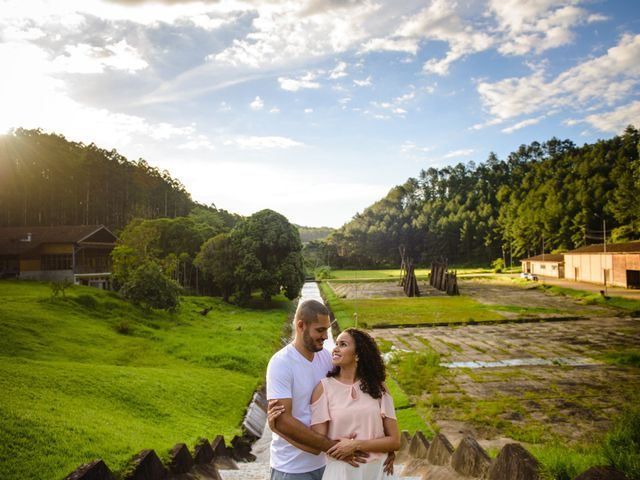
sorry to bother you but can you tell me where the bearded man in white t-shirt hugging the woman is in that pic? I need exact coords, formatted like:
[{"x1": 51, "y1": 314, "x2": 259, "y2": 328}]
[{"x1": 267, "y1": 300, "x2": 334, "y2": 480}]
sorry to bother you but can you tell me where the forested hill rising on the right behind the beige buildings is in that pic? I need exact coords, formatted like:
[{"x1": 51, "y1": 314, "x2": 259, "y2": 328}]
[{"x1": 323, "y1": 126, "x2": 640, "y2": 267}]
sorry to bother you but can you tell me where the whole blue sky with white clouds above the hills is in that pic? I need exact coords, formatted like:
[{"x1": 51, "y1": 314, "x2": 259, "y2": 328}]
[{"x1": 0, "y1": 0, "x2": 640, "y2": 227}]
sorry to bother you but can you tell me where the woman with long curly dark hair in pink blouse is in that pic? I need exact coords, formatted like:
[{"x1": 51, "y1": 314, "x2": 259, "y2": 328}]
[{"x1": 311, "y1": 328, "x2": 400, "y2": 480}]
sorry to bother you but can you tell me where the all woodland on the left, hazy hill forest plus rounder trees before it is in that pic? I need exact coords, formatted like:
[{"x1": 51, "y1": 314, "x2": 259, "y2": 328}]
[{"x1": 0, "y1": 128, "x2": 304, "y2": 309}]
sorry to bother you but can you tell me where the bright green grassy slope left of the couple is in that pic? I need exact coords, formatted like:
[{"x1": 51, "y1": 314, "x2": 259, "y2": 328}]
[{"x1": 0, "y1": 281, "x2": 290, "y2": 479}]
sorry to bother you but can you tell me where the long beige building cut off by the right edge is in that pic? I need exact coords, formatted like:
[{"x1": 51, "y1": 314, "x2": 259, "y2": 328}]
[{"x1": 564, "y1": 241, "x2": 640, "y2": 288}]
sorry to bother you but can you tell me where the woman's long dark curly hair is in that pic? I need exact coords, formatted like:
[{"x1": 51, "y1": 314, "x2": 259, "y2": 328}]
[{"x1": 327, "y1": 328, "x2": 386, "y2": 398}]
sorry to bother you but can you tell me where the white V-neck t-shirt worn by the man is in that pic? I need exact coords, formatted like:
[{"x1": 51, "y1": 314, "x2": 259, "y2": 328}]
[{"x1": 267, "y1": 344, "x2": 333, "y2": 473}]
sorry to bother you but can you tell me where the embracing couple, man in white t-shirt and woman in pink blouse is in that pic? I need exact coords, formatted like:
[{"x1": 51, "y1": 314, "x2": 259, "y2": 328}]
[{"x1": 267, "y1": 300, "x2": 400, "y2": 480}]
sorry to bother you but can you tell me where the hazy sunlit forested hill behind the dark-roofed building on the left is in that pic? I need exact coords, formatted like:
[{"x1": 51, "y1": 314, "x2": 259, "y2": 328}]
[{"x1": 0, "y1": 129, "x2": 195, "y2": 230}]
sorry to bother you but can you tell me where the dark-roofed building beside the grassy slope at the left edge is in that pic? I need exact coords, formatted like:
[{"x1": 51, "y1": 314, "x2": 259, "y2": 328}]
[{"x1": 0, "y1": 225, "x2": 117, "y2": 288}]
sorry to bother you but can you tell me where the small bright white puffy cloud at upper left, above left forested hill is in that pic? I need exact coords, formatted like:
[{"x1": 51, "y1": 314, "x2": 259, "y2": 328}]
[{"x1": 52, "y1": 40, "x2": 149, "y2": 73}]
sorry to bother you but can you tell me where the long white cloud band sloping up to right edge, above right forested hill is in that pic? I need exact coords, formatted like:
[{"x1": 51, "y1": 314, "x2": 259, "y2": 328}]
[{"x1": 478, "y1": 35, "x2": 640, "y2": 125}]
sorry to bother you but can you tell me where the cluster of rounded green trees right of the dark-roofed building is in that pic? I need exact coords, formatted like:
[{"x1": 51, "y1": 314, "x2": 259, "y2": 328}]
[{"x1": 112, "y1": 210, "x2": 304, "y2": 310}]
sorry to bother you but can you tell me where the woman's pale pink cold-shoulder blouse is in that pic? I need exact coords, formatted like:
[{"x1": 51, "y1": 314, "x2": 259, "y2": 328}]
[{"x1": 311, "y1": 377, "x2": 396, "y2": 461}]
